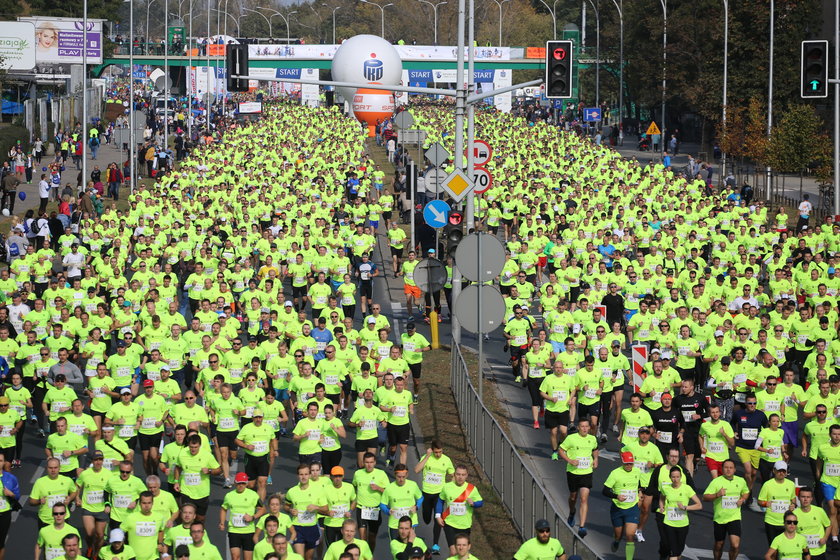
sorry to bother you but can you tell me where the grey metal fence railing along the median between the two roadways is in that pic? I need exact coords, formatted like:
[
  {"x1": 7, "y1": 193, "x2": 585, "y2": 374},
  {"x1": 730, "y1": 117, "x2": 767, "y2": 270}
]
[{"x1": 450, "y1": 345, "x2": 601, "y2": 560}]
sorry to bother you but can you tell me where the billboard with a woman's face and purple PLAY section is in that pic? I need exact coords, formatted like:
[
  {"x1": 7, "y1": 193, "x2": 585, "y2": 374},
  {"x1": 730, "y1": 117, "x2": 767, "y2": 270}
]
[{"x1": 18, "y1": 16, "x2": 102, "y2": 64}]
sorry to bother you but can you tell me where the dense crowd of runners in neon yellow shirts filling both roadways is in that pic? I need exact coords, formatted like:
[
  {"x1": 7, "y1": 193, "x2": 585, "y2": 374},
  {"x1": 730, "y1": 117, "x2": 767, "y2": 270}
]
[{"x1": 0, "y1": 97, "x2": 840, "y2": 560}]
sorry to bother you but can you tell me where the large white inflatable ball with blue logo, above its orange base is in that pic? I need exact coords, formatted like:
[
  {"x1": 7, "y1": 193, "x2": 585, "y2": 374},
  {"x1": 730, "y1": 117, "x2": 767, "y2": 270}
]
[{"x1": 332, "y1": 35, "x2": 402, "y2": 103}]
